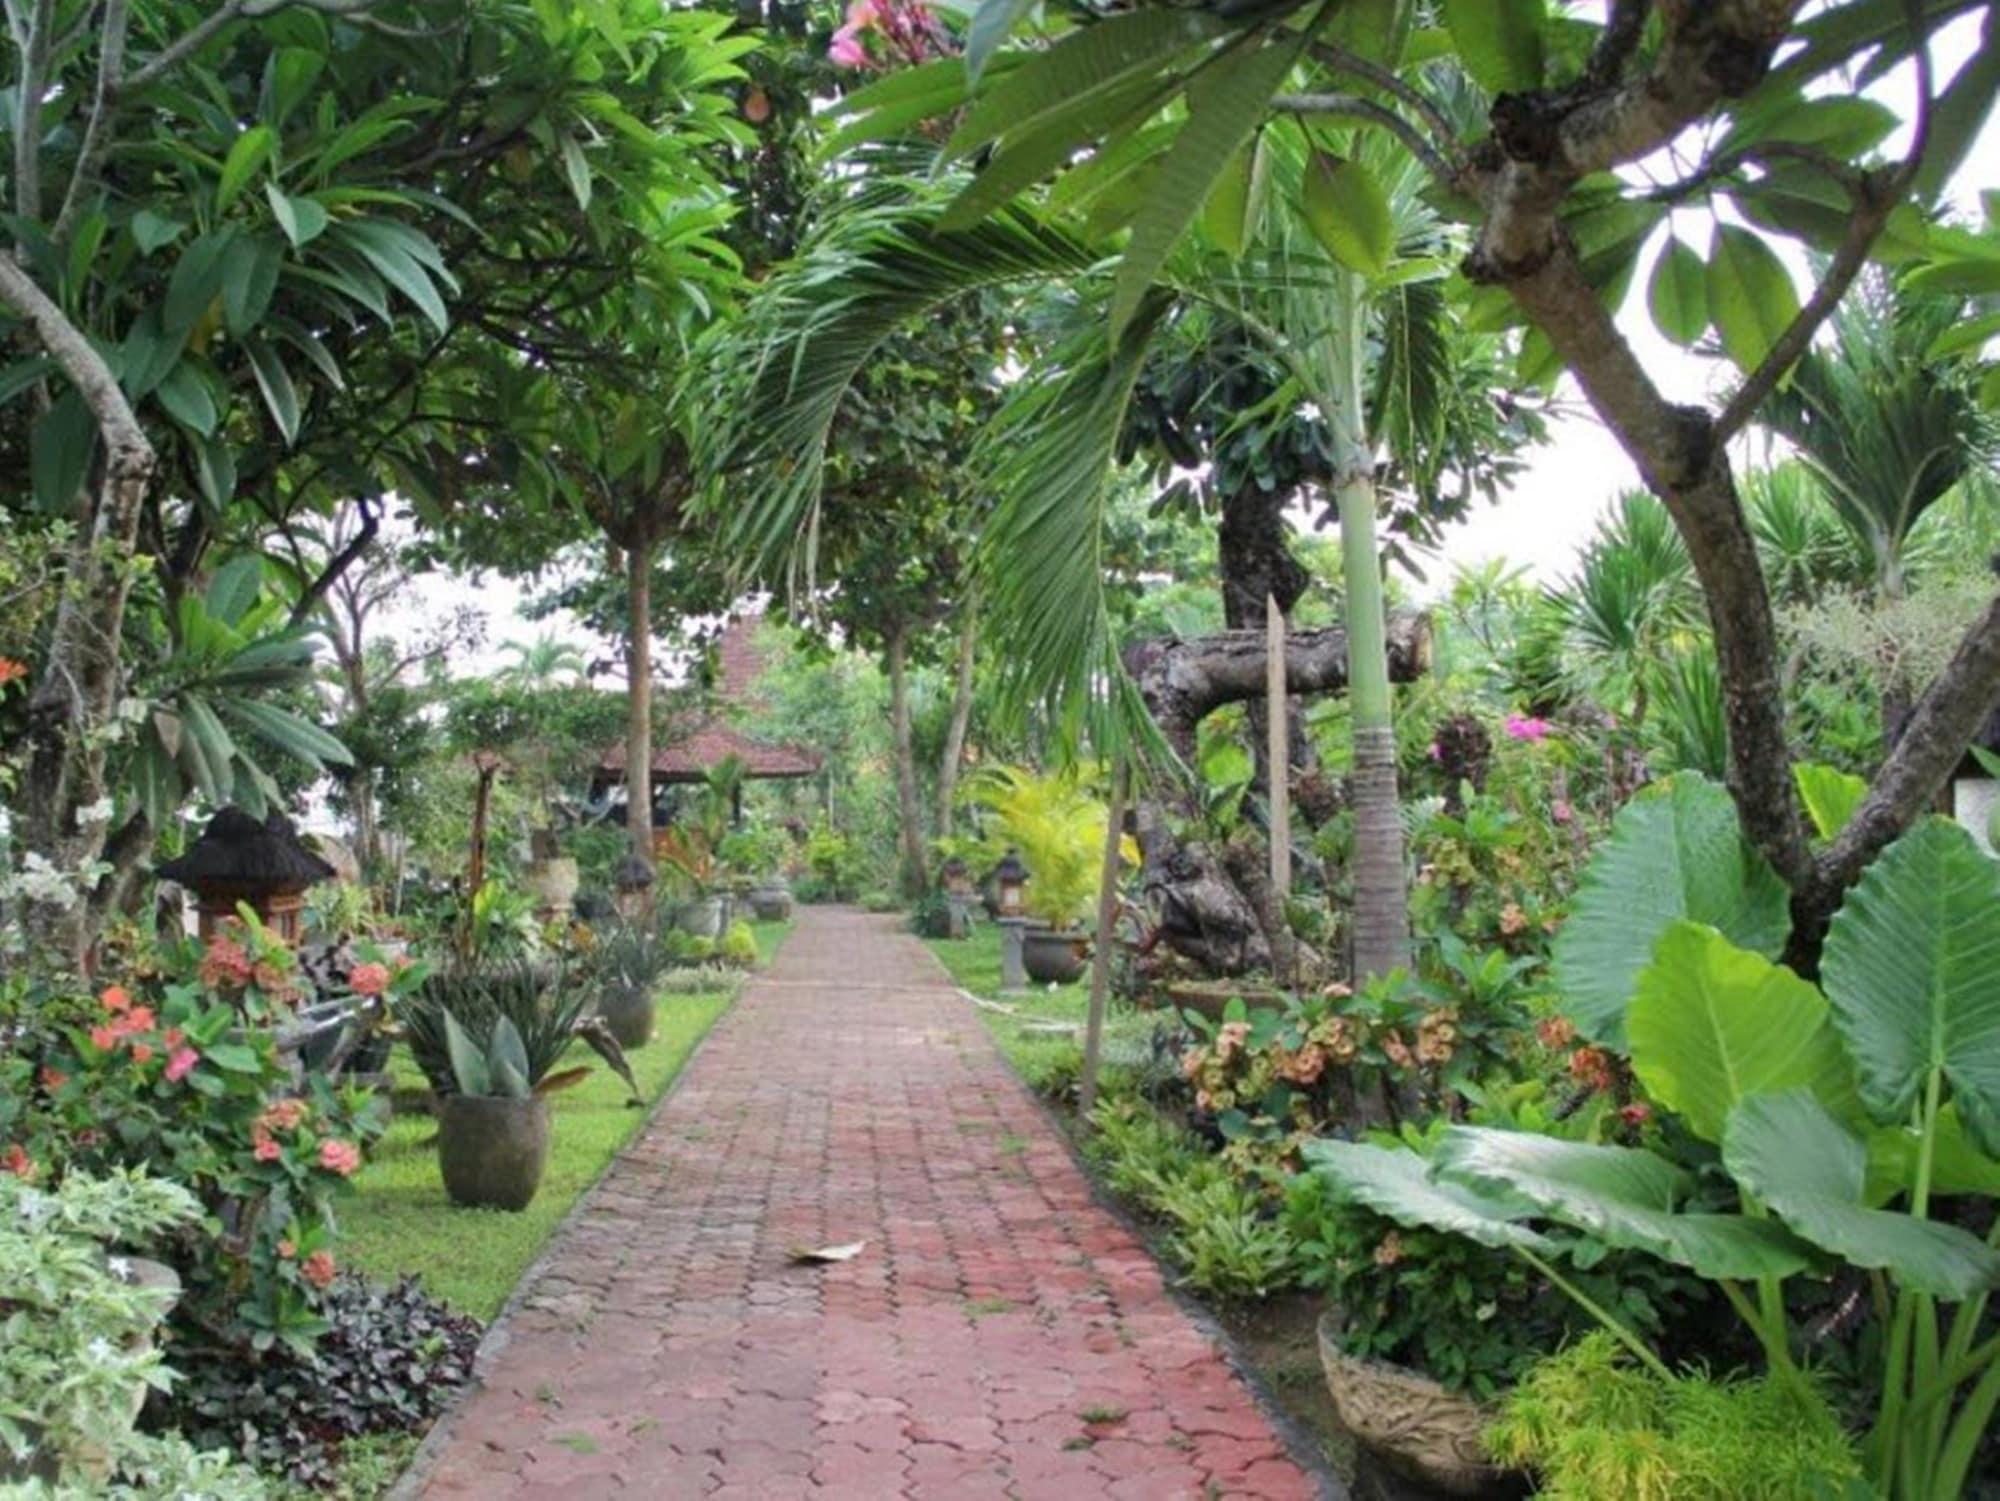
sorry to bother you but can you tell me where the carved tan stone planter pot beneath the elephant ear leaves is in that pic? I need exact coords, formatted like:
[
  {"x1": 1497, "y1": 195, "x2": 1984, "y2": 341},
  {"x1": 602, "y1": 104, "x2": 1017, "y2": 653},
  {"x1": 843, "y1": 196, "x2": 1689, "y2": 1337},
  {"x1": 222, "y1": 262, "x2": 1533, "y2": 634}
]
[{"x1": 1320, "y1": 1313, "x2": 1522, "y2": 1501}]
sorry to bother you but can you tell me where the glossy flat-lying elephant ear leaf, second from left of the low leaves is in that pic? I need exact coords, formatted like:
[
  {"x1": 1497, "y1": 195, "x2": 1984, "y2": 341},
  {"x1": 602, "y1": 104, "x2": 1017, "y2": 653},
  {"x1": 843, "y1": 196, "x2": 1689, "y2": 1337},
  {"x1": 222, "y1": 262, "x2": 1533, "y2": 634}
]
[{"x1": 1436, "y1": 1127, "x2": 1808, "y2": 1279}]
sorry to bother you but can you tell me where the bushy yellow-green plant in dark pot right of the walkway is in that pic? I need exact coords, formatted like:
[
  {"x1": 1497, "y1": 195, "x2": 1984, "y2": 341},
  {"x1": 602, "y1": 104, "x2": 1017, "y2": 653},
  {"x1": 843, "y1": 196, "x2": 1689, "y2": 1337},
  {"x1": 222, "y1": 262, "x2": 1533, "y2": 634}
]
[{"x1": 972, "y1": 767, "x2": 1130, "y2": 985}]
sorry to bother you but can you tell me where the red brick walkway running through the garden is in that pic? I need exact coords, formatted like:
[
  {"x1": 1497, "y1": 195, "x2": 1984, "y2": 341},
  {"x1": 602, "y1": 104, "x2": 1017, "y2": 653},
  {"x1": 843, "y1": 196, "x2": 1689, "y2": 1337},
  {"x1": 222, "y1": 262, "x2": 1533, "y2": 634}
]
[{"x1": 404, "y1": 909, "x2": 1318, "y2": 1501}]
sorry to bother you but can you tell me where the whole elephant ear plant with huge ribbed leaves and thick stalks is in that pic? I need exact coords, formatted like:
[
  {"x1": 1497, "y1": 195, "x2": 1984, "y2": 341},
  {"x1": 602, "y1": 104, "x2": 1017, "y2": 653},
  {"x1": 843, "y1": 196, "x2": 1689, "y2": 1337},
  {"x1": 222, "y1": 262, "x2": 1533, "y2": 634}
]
[{"x1": 1306, "y1": 777, "x2": 2000, "y2": 1501}]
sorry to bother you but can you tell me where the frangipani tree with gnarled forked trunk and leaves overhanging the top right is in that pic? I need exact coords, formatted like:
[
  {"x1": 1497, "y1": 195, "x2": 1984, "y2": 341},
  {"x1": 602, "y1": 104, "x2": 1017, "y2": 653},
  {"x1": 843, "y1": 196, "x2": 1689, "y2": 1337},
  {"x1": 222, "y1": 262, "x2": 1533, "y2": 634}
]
[{"x1": 804, "y1": 0, "x2": 2000, "y2": 957}]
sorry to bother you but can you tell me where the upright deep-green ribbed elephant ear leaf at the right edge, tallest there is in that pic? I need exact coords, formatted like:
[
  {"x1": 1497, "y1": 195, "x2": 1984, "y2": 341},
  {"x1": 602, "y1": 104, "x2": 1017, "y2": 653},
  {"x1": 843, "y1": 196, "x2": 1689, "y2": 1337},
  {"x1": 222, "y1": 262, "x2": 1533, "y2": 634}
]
[{"x1": 1820, "y1": 817, "x2": 2000, "y2": 1155}]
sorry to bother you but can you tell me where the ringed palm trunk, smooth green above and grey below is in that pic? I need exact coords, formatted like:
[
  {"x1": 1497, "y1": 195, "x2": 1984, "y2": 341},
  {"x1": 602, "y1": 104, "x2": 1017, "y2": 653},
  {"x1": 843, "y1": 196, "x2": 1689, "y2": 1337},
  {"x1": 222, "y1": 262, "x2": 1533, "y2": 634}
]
[{"x1": 1336, "y1": 472, "x2": 1410, "y2": 981}]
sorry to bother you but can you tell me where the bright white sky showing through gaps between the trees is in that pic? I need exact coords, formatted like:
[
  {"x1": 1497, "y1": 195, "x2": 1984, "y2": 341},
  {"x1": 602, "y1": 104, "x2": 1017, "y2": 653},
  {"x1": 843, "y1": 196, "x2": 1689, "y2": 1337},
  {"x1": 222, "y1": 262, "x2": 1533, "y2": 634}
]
[{"x1": 382, "y1": 16, "x2": 2000, "y2": 672}]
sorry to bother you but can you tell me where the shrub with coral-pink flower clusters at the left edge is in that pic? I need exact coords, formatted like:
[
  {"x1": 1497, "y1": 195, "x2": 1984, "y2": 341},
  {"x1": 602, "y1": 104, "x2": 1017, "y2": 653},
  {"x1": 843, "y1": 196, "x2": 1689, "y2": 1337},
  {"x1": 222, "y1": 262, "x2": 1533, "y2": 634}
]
[{"x1": 0, "y1": 929, "x2": 394, "y2": 1351}]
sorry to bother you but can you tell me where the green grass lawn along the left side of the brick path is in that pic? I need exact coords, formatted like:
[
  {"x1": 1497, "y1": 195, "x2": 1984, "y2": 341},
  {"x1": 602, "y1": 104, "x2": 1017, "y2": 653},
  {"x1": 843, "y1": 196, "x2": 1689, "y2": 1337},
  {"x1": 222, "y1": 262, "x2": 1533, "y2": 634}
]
[{"x1": 336, "y1": 923, "x2": 790, "y2": 1319}]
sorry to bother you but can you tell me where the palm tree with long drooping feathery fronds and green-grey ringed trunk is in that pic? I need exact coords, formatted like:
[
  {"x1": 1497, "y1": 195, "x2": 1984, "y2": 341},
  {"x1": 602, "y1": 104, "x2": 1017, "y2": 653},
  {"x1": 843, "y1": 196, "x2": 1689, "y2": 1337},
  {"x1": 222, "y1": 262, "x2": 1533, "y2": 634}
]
[{"x1": 716, "y1": 132, "x2": 1504, "y2": 988}]
